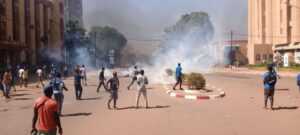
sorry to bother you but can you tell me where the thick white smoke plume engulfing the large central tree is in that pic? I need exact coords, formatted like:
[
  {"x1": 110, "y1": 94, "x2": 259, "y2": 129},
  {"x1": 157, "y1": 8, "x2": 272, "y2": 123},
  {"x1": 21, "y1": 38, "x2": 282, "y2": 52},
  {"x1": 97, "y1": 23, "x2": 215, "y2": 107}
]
[{"x1": 142, "y1": 12, "x2": 223, "y2": 83}]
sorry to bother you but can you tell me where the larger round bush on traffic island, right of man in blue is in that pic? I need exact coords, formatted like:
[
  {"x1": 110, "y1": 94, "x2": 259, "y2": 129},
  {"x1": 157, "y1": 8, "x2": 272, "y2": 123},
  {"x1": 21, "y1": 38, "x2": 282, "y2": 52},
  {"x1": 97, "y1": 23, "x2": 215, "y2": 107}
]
[{"x1": 183, "y1": 73, "x2": 206, "y2": 90}]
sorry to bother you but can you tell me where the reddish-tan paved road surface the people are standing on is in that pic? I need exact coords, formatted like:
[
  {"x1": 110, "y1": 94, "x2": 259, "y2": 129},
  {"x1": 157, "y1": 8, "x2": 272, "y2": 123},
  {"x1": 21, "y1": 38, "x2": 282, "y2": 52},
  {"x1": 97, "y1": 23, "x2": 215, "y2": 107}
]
[{"x1": 0, "y1": 73, "x2": 300, "y2": 135}]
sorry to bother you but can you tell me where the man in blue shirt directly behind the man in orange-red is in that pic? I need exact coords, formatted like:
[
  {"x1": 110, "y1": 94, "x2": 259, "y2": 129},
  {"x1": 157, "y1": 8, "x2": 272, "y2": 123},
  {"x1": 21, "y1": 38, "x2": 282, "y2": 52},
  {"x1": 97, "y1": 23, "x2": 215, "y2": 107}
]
[{"x1": 50, "y1": 73, "x2": 68, "y2": 115}]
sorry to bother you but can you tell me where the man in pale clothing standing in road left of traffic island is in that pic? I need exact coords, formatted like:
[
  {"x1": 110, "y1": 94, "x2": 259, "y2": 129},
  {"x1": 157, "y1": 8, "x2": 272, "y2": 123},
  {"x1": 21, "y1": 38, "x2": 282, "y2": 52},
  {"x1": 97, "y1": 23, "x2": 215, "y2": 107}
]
[{"x1": 136, "y1": 70, "x2": 149, "y2": 108}]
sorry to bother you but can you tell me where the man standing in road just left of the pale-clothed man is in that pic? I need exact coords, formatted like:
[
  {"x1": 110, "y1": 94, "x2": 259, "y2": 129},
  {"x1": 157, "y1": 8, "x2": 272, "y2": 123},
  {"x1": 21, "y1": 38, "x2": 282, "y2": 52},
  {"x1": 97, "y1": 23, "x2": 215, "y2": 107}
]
[{"x1": 106, "y1": 72, "x2": 120, "y2": 109}]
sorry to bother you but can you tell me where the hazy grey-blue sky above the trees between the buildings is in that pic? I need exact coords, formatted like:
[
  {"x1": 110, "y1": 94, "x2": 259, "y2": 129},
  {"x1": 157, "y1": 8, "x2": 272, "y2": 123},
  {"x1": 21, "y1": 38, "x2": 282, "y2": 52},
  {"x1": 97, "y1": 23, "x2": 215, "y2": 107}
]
[{"x1": 83, "y1": 0, "x2": 247, "y2": 39}]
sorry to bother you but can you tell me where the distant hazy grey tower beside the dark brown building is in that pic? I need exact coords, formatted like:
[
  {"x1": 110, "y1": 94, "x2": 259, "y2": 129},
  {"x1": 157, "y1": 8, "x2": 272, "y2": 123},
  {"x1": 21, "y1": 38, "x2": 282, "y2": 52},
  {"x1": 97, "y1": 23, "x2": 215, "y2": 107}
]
[{"x1": 64, "y1": 0, "x2": 83, "y2": 27}]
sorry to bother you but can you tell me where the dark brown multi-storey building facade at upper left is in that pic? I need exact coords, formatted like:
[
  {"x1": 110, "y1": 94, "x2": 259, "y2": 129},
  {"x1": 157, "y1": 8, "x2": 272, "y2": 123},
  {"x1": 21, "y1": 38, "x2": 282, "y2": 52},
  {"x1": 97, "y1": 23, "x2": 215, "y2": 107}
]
[{"x1": 0, "y1": 0, "x2": 63, "y2": 65}]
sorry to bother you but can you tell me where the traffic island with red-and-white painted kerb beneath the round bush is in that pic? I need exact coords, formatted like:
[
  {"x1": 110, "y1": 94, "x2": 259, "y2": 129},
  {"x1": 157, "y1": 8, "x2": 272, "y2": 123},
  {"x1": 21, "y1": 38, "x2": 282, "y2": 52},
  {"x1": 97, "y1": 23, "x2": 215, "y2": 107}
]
[{"x1": 165, "y1": 85, "x2": 226, "y2": 100}]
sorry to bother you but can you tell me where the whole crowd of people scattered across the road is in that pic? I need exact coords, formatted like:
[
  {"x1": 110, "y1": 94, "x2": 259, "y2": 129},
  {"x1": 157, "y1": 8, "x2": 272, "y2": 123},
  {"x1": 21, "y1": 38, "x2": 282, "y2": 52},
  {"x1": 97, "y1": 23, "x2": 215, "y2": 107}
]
[{"x1": 0, "y1": 63, "x2": 300, "y2": 135}]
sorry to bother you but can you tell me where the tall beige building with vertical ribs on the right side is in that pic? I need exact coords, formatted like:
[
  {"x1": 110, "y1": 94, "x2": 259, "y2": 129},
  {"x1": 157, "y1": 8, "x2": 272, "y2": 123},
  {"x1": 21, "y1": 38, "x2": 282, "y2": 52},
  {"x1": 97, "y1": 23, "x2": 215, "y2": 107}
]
[{"x1": 248, "y1": 0, "x2": 300, "y2": 64}]
